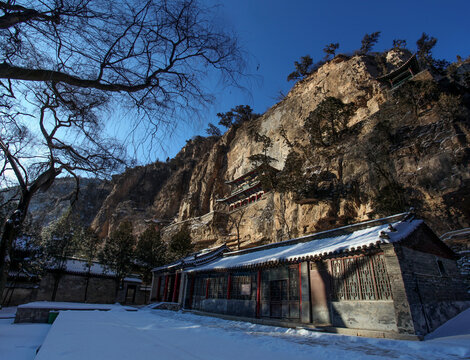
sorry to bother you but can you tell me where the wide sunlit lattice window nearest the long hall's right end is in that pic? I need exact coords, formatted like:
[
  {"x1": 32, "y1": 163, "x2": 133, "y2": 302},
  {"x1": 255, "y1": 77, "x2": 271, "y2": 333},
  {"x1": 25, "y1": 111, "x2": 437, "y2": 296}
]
[{"x1": 330, "y1": 254, "x2": 392, "y2": 301}]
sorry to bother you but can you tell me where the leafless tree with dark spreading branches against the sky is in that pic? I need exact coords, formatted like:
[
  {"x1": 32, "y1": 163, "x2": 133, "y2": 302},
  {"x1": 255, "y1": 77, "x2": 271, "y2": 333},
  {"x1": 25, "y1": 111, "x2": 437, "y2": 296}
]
[{"x1": 0, "y1": 0, "x2": 242, "y2": 306}]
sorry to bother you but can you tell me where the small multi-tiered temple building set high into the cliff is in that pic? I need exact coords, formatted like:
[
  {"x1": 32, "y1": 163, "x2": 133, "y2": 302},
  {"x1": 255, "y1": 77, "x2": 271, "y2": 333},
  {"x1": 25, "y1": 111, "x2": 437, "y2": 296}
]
[{"x1": 217, "y1": 168, "x2": 272, "y2": 211}]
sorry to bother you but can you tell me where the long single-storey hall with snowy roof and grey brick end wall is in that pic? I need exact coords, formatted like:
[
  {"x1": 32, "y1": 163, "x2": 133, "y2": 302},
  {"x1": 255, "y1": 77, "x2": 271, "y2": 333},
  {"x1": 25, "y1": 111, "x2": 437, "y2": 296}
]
[{"x1": 151, "y1": 213, "x2": 470, "y2": 339}]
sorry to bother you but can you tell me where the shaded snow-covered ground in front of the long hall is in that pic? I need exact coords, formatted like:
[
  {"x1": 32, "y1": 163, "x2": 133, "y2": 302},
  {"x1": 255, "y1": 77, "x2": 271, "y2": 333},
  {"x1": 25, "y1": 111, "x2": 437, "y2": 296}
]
[{"x1": 0, "y1": 308, "x2": 470, "y2": 360}]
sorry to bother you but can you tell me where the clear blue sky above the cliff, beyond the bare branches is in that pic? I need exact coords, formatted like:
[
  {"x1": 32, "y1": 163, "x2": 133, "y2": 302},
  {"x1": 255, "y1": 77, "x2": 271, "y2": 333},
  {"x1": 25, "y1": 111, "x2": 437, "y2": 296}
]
[{"x1": 142, "y1": 0, "x2": 470, "y2": 161}]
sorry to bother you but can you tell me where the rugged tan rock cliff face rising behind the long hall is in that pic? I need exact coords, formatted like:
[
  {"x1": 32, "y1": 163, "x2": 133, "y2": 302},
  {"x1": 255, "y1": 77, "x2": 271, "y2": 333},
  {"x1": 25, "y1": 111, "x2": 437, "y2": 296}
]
[{"x1": 93, "y1": 52, "x2": 470, "y2": 247}]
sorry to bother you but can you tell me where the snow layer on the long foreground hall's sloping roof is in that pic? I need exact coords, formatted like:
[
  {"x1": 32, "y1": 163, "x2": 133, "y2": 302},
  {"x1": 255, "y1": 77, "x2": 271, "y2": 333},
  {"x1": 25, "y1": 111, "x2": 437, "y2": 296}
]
[{"x1": 190, "y1": 220, "x2": 423, "y2": 271}]
